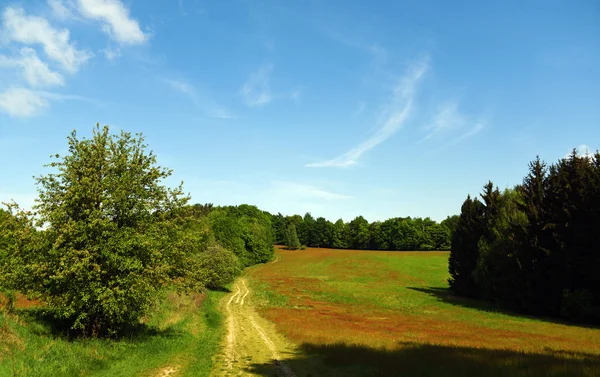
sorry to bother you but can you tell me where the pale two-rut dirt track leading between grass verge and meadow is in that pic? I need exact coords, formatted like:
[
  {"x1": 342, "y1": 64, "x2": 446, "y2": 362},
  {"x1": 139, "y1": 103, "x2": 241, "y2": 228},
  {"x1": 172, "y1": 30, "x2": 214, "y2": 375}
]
[{"x1": 211, "y1": 277, "x2": 295, "y2": 377}]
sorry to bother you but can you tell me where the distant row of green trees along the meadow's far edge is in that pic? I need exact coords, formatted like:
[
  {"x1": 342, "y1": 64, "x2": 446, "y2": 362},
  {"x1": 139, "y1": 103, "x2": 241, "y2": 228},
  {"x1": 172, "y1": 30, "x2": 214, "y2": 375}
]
[{"x1": 271, "y1": 213, "x2": 458, "y2": 251}]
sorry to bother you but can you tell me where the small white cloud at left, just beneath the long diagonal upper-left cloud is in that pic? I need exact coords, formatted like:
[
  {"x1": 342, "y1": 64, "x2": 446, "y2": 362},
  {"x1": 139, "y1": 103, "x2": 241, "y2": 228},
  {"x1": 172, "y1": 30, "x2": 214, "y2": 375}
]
[{"x1": 0, "y1": 47, "x2": 65, "y2": 87}]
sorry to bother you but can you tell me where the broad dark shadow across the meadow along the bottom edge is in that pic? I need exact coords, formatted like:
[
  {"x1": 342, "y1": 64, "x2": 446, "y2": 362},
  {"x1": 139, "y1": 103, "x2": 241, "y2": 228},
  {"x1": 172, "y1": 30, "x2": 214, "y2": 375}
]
[{"x1": 247, "y1": 343, "x2": 600, "y2": 377}]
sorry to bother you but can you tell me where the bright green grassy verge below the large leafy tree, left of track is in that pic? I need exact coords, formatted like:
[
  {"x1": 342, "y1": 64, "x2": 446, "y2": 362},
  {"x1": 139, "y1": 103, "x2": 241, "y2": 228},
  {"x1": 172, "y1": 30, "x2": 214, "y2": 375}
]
[{"x1": 0, "y1": 292, "x2": 224, "y2": 376}]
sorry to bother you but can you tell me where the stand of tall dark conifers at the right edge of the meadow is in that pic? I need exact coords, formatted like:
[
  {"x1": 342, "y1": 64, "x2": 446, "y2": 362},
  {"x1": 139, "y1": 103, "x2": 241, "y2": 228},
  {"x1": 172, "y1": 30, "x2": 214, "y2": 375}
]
[{"x1": 449, "y1": 151, "x2": 600, "y2": 321}]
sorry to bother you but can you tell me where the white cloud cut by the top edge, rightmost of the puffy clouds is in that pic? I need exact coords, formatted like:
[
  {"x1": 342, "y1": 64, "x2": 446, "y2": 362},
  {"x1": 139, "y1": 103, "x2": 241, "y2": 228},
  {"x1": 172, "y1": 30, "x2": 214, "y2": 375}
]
[{"x1": 77, "y1": 0, "x2": 149, "y2": 44}]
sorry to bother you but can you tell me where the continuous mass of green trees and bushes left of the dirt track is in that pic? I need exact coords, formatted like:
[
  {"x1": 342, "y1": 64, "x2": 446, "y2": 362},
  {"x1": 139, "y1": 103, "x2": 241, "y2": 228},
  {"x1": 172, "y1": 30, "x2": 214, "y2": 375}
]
[{"x1": 0, "y1": 126, "x2": 274, "y2": 336}]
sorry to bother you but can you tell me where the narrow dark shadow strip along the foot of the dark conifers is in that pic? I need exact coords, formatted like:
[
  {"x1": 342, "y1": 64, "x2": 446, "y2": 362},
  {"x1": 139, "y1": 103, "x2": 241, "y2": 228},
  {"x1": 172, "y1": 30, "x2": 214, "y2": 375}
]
[{"x1": 407, "y1": 287, "x2": 600, "y2": 329}]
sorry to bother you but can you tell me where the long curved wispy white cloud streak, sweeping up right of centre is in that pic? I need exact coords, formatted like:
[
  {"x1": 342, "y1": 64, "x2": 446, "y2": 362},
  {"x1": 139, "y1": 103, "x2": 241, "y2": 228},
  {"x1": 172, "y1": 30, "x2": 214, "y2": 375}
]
[{"x1": 306, "y1": 57, "x2": 429, "y2": 168}]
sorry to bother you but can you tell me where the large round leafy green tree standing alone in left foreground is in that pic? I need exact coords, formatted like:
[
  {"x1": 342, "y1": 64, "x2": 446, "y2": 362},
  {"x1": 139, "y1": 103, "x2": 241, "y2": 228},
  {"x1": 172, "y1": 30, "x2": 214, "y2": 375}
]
[{"x1": 0, "y1": 125, "x2": 193, "y2": 335}]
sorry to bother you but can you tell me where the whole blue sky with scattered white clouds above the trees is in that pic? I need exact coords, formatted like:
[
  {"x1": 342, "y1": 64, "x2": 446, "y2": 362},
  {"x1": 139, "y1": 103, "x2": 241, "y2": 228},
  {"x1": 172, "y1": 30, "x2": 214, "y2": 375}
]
[{"x1": 0, "y1": 0, "x2": 600, "y2": 221}]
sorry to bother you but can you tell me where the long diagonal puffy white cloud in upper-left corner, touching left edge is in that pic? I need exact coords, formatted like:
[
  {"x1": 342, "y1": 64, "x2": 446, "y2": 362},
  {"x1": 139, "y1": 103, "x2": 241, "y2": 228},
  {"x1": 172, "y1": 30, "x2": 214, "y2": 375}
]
[{"x1": 2, "y1": 7, "x2": 93, "y2": 73}]
